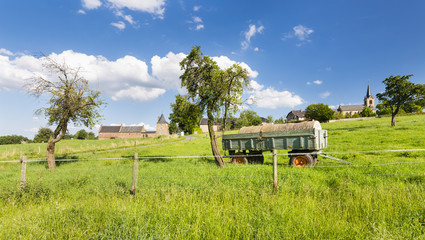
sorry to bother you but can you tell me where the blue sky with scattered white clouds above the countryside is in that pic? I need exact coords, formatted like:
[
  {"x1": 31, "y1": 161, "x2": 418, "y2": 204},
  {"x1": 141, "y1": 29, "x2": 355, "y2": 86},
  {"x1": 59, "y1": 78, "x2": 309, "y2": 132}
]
[{"x1": 0, "y1": 0, "x2": 425, "y2": 138}]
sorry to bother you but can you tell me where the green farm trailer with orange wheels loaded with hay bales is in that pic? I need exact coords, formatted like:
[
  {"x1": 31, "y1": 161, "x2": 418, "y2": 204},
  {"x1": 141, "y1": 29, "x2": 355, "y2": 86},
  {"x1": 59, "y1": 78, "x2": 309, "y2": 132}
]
[{"x1": 222, "y1": 121, "x2": 328, "y2": 167}]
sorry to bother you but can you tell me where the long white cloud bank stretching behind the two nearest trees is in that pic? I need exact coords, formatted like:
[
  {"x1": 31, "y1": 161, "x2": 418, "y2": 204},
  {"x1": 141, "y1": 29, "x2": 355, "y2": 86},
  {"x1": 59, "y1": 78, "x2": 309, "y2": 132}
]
[{"x1": 0, "y1": 50, "x2": 258, "y2": 101}]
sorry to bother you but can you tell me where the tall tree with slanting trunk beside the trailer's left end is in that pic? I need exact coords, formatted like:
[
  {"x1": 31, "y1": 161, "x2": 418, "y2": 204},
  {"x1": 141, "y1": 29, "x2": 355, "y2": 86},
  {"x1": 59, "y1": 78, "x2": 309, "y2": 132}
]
[{"x1": 180, "y1": 46, "x2": 249, "y2": 167}]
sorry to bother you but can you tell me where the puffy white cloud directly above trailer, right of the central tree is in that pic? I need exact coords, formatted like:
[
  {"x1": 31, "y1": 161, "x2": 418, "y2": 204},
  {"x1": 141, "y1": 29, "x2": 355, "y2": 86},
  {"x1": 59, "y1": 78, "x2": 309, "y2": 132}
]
[{"x1": 248, "y1": 80, "x2": 304, "y2": 109}]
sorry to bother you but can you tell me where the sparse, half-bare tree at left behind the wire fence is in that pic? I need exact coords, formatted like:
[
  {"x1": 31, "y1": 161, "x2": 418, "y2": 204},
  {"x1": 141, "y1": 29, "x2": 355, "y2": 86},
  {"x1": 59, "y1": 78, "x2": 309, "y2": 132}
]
[{"x1": 26, "y1": 57, "x2": 103, "y2": 170}]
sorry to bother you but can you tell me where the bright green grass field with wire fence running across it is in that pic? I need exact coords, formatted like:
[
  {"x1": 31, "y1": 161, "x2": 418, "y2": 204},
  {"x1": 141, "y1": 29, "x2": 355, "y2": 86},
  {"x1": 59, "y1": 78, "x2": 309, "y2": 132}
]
[{"x1": 0, "y1": 115, "x2": 425, "y2": 239}]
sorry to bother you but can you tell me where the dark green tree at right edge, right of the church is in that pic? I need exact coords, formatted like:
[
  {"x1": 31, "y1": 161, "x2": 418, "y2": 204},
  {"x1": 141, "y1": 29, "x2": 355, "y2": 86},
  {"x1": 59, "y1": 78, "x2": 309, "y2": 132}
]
[{"x1": 376, "y1": 74, "x2": 425, "y2": 126}]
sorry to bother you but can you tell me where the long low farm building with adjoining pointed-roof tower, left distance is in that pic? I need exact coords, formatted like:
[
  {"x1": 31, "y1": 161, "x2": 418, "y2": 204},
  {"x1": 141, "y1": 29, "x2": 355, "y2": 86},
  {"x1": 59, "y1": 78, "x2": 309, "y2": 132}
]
[{"x1": 99, "y1": 114, "x2": 170, "y2": 140}]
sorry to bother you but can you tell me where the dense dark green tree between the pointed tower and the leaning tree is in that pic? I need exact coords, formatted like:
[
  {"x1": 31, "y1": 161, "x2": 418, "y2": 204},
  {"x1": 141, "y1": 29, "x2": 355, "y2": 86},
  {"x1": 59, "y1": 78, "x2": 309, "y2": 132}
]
[{"x1": 169, "y1": 95, "x2": 202, "y2": 134}]
